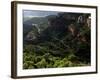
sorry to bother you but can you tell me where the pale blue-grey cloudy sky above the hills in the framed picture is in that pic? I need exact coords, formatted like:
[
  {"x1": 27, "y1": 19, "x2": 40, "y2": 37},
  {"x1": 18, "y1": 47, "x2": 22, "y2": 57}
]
[{"x1": 23, "y1": 10, "x2": 58, "y2": 17}]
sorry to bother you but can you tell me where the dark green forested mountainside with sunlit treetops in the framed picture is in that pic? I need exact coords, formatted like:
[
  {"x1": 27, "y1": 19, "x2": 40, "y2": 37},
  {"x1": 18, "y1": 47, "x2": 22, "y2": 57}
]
[{"x1": 23, "y1": 13, "x2": 91, "y2": 69}]
